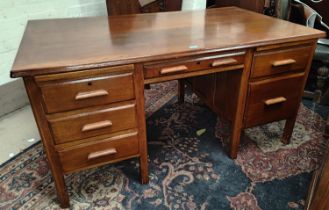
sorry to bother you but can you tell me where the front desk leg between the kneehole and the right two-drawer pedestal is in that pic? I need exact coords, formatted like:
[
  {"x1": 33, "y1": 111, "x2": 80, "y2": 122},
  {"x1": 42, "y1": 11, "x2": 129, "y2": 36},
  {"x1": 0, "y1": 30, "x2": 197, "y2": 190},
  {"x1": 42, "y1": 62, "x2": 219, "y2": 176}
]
[{"x1": 230, "y1": 50, "x2": 253, "y2": 159}]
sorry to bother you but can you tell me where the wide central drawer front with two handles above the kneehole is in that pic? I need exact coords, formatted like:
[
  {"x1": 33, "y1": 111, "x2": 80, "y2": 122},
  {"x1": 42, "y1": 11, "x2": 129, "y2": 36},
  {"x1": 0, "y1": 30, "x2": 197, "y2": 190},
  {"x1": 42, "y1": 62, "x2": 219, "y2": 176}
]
[{"x1": 144, "y1": 52, "x2": 245, "y2": 79}]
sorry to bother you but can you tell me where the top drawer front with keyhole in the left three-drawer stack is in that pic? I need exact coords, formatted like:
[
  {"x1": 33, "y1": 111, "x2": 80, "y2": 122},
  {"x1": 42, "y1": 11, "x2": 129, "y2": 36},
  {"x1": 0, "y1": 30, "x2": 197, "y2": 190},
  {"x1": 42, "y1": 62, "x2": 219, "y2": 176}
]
[{"x1": 36, "y1": 72, "x2": 135, "y2": 113}]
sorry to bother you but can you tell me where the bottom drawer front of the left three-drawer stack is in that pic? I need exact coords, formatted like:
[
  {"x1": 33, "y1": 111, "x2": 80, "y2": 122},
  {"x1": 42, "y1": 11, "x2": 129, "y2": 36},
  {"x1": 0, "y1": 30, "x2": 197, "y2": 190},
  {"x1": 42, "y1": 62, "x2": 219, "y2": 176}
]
[{"x1": 58, "y1": 134, "x2": 139, "y2": 173}]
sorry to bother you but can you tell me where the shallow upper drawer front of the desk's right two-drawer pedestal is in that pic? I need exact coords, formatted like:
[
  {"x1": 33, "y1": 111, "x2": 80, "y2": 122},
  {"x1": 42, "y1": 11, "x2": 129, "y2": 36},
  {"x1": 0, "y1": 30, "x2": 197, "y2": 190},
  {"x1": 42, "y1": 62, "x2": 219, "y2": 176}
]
[{"x1": 251, "y1": 46, "x2": 313, "y2": 78}]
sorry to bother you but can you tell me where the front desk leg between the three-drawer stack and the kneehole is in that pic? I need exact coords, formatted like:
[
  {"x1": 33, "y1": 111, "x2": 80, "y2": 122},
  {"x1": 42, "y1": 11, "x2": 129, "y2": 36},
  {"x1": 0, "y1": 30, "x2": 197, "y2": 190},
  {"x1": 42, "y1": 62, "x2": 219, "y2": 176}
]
[{"x1": 135, "y1": 65, "x2": 149, "y2": 184}]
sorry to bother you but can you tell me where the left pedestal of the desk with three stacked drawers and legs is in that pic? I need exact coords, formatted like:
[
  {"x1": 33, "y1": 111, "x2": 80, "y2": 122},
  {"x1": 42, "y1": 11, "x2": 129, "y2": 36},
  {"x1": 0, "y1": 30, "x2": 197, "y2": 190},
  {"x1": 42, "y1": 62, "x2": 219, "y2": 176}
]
[{"x1": 24, "y1": 65, "x2": 148, "y2": 208}]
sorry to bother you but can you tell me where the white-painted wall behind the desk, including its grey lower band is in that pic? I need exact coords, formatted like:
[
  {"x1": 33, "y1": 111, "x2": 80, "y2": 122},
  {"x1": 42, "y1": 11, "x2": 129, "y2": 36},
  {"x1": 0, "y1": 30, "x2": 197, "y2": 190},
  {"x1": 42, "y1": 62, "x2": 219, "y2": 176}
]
[{"x1": 0, "y1": 0, "x2": 206, "y2": 116}]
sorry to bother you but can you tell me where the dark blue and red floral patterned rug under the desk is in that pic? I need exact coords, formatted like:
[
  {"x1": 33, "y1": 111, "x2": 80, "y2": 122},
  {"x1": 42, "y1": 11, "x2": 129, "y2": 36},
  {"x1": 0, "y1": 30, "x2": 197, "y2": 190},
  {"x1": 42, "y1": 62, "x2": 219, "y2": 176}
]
[{"x1": 0, "y1": 82, "x2": 328, "y2": 210}]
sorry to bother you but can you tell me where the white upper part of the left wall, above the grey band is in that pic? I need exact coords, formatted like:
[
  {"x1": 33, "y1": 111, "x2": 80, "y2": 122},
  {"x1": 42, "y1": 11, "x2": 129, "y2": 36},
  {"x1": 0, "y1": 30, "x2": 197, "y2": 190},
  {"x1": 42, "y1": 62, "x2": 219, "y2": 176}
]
[{"x1": 0, "y1": 0, "x2": 107, "y2": 86}]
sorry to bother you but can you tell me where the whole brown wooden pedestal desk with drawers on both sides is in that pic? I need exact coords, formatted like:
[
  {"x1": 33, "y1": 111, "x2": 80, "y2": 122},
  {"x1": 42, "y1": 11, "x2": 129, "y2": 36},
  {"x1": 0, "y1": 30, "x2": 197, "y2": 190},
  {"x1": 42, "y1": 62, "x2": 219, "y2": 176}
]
[{"x1": 11, "y1": 7, "x2": 325, "y2": 207}]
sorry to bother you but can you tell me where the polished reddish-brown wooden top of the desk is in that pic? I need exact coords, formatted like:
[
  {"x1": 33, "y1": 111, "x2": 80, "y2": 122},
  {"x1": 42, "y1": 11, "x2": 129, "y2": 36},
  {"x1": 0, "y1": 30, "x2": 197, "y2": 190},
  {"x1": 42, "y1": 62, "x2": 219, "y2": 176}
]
[{"x1": 11, "y1": 7, "x2": 325, "y2": 77}]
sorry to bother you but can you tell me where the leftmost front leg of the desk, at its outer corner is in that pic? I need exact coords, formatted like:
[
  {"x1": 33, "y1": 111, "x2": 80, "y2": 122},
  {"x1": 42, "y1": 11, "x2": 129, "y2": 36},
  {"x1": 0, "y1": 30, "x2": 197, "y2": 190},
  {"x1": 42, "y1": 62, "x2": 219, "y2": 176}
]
[{"x1": 24, "y1": 77, "x2": 70, "y2": 208}]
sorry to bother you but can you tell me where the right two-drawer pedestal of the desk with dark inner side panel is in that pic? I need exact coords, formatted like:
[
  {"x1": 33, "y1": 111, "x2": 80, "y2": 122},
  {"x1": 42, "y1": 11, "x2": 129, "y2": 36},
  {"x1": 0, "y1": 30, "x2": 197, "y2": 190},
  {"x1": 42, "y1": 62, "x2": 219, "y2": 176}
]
[{"x1": 187, "y1": 42, "x2": 314, "y2": 152}]
